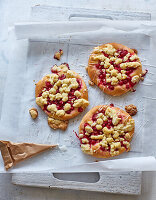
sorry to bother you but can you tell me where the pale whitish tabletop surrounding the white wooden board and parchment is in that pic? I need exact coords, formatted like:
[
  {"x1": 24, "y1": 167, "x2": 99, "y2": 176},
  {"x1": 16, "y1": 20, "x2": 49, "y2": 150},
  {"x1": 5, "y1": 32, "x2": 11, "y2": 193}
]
[{"x1": 0, "y1": 0, "x2": 156, "y2": 200}]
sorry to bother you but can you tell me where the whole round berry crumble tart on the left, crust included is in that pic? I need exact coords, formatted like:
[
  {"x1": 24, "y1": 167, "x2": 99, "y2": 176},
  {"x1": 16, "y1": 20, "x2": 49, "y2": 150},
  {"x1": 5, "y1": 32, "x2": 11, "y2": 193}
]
[{"x1": 35, "y1": 63, "x2": 89, "y2": 120}]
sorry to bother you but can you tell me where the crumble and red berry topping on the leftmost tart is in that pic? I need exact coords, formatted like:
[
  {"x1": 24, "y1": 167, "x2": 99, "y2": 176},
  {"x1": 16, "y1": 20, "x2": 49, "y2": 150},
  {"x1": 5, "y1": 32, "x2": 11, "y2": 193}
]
[{"x1": 36, "y1": 63, "x2": 89, "y2": 117}]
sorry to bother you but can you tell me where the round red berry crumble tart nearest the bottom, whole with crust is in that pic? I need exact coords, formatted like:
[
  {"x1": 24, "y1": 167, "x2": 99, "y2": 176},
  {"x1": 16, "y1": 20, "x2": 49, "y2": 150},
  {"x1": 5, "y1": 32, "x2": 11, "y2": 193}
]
[{"x1": 79, "y1": 105, "x2": 135, "y2": 158}]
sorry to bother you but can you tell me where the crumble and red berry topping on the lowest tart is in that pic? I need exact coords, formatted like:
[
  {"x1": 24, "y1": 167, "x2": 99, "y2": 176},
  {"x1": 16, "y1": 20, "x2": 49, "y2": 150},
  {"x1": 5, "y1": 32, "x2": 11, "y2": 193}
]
[{"x1": 79, "y1": 106, "x2": 134, "y2": 156}]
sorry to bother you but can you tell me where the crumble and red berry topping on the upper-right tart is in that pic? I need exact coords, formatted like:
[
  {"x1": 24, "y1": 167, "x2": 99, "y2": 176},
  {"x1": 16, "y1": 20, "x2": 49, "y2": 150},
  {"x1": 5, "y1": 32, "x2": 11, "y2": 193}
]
[{"x1": 91, "y1": 44, "x2": 141, "y2": 90}]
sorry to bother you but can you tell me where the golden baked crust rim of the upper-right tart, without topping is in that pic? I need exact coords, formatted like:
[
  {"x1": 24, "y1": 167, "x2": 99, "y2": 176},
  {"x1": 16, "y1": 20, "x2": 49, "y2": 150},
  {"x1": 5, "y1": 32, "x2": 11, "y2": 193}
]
[{"x1": 87, "y1": 43, "x2": 142, "y2": 96}]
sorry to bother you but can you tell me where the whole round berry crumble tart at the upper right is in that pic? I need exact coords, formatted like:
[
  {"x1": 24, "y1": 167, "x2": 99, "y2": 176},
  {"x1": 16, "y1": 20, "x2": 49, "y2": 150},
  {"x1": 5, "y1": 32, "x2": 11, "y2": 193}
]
[{"x1": 87, "y1": 43, "x2": 143, "y2": 96}]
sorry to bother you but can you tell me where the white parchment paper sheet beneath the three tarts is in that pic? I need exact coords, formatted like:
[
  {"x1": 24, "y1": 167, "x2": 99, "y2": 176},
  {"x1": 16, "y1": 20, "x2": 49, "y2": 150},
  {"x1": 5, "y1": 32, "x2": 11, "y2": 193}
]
[{"x1": 0, "y1": 22, "x2": 156, "y2": 172}]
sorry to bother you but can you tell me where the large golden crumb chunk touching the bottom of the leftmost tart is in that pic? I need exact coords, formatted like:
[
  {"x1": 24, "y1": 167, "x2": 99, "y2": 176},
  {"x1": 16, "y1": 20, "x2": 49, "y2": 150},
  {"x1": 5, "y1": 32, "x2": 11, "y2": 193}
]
[{"x1": 48, "y1": 117, "x2": 68, "y2": 130}]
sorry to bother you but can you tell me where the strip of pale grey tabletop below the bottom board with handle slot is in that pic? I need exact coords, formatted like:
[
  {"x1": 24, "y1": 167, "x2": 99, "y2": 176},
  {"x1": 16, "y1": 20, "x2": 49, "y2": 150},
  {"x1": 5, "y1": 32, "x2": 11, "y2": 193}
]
[{"x1": 0, "y1": 172, "x2": 156, "y2": 200}]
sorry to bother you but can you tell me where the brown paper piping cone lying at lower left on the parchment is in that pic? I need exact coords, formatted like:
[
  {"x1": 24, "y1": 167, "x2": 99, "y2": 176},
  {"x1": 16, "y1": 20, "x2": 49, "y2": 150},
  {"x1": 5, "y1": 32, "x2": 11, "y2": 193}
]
[{"x1": 0, "y1": 140, "x2": 57, "y2": 170}]
